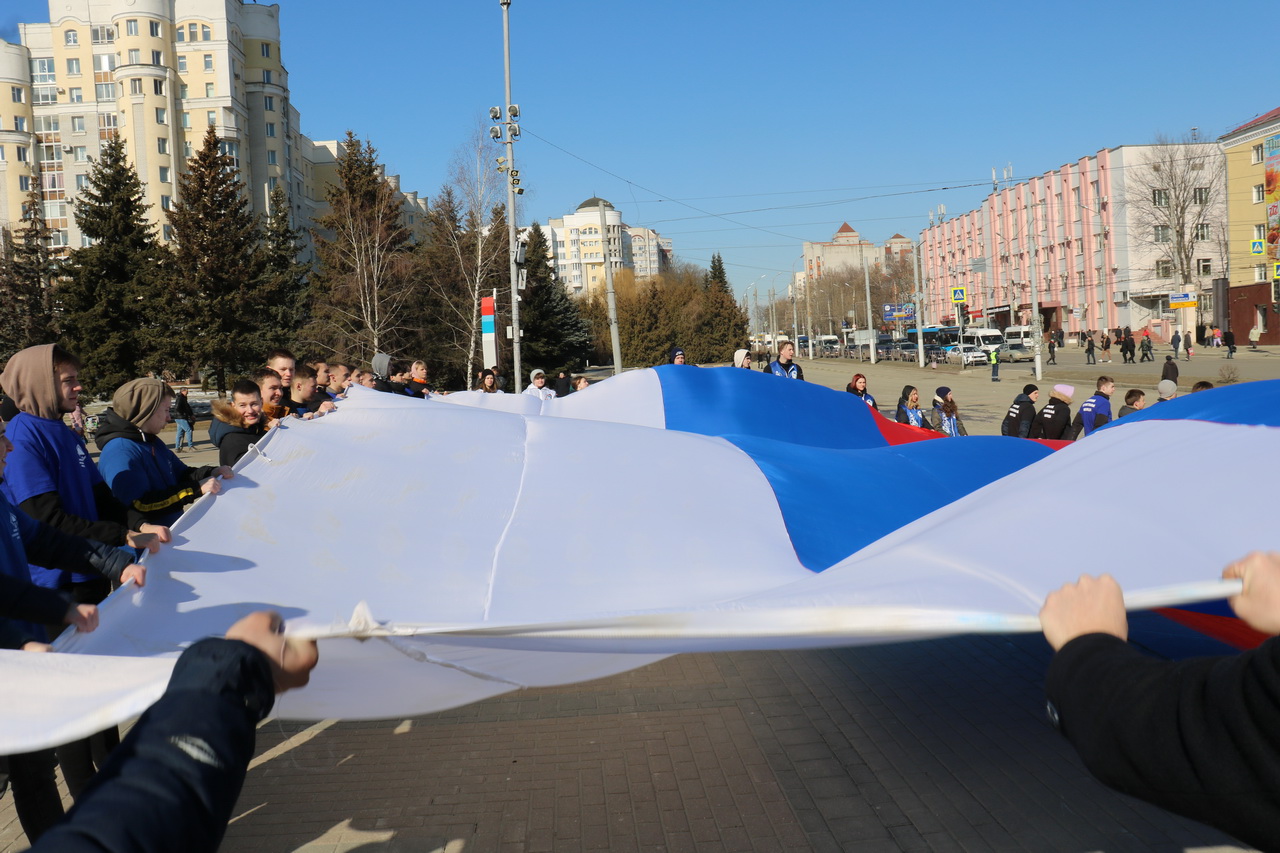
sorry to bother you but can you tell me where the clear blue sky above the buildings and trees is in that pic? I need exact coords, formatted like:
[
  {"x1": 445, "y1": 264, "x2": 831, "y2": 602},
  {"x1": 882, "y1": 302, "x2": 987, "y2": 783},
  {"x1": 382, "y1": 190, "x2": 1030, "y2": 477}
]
[{"x1": 0, "y1": 0, "x2": 1280, "y2": 292}]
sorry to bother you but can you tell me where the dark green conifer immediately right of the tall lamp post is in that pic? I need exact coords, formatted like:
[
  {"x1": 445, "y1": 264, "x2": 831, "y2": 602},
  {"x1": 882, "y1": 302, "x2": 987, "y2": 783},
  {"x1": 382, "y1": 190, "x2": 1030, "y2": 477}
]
[{"x1": 520, "y1": 223, "x2": 591, "y2": 377}]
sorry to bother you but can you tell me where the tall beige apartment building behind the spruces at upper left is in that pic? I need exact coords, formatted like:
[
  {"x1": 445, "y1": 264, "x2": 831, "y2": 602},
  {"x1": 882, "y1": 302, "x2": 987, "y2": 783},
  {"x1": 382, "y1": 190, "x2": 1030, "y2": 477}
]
[{"x1": 0, "y1": 0, "x2": 426, "y2": 256}]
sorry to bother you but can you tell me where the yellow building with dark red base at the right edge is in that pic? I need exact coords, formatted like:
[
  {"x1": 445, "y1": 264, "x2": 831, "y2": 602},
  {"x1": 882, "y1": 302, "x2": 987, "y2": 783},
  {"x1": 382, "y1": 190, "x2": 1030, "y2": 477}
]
[{"x1": 1219, "y1": 108, "x2": 1280, "y2": 346}]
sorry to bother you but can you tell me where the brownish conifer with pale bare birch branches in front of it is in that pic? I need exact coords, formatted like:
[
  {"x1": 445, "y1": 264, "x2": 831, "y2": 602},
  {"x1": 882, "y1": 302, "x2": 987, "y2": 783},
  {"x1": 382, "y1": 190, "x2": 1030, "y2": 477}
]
[{"x1": 311, "y1": 131, "x2": 419, "y2": 361}]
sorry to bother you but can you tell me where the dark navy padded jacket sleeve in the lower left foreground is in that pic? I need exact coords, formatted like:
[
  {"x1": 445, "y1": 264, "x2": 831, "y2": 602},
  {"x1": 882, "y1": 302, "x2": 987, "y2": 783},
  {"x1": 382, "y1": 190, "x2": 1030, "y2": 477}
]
[{"x1": 31, "y1": 639, "x2": 274, "y2": 853}]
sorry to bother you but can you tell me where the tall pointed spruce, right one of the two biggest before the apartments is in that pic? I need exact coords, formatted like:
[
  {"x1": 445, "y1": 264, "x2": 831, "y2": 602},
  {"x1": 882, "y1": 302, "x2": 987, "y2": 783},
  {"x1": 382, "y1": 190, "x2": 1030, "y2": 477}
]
[{"x1": 164, "y1": 126, "x2": 266, "y2": 393}]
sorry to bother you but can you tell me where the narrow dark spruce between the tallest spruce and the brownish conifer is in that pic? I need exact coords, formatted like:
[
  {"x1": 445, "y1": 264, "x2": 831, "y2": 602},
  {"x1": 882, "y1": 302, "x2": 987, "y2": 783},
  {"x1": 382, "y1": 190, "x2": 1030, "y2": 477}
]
[{"x1": 248, "y1": 186, "x2": 311, "y2": 353}]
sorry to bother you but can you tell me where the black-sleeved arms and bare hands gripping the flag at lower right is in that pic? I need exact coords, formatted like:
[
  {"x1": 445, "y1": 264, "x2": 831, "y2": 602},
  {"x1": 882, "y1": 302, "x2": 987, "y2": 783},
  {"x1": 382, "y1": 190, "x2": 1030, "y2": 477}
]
[{"x1": 1041, "y1": 553, "x2": 1280, "y2": 850}]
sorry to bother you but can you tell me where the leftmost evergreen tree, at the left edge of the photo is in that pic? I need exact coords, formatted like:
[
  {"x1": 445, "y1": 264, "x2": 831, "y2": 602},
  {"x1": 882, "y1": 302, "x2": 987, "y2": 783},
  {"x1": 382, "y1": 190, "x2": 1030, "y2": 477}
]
[{"x1": 0, "y1": 173, "x2": 59, "y2": 360}]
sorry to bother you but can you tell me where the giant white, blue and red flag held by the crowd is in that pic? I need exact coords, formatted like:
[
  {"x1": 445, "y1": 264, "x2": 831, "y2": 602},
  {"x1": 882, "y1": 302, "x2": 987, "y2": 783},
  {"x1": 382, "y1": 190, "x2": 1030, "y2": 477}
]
[{"x1": 0, "y1": 366, "x2": 1280, "y2": 754}]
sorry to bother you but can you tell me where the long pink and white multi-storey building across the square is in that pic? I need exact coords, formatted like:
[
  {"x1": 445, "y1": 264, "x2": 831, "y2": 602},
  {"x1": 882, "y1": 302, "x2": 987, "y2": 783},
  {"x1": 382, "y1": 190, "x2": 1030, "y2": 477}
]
[{"x1": 920, "y1": 146, "x2": 1222, "y2": 333}]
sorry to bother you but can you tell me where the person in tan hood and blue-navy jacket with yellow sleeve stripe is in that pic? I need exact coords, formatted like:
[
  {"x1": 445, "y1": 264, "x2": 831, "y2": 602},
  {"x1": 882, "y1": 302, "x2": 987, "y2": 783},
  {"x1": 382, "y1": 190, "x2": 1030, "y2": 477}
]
[{"x1": 93, "y1": 379, "x2": 233, "y2": 525}]
